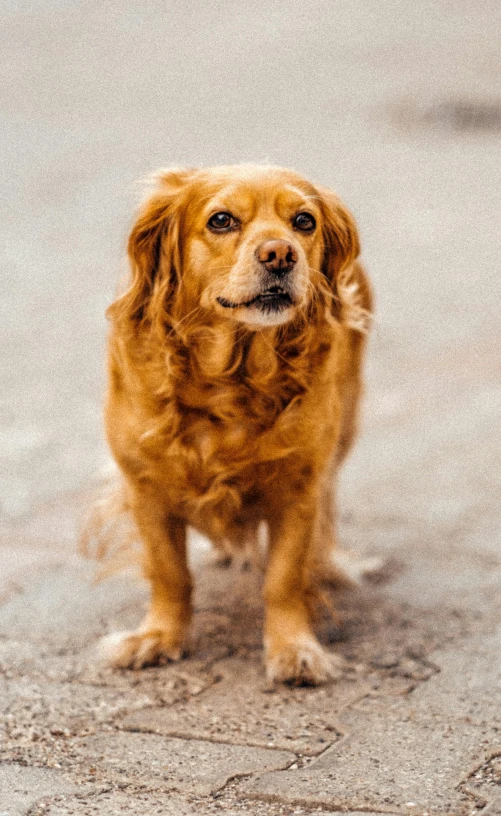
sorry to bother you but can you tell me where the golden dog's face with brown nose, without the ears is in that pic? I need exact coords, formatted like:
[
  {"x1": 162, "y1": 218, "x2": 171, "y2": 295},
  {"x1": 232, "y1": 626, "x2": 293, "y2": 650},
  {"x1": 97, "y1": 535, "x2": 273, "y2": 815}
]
[{"x1": 184, "y1": 168, "x2": 323, "y2": 327}]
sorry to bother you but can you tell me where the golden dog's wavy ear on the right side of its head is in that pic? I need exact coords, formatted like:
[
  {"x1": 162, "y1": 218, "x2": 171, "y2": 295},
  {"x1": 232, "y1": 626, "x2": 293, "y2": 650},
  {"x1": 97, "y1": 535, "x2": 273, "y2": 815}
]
[{"x1": 317, "y1": 186, "x2": 370, "y2": 331}]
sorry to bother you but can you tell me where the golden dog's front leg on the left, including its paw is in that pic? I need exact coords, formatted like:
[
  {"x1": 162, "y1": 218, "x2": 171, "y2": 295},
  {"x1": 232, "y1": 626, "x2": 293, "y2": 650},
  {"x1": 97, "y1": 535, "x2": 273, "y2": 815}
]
[{"x1": 102, "y1": 493, "x2": 192, "y2": 669}]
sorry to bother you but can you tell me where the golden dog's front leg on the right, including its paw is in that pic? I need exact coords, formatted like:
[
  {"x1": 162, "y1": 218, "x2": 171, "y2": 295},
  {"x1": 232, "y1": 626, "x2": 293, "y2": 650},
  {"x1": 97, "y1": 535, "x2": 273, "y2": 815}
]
[{"x1": 264, "y1": 501, "x2": 335, "y2": 685}]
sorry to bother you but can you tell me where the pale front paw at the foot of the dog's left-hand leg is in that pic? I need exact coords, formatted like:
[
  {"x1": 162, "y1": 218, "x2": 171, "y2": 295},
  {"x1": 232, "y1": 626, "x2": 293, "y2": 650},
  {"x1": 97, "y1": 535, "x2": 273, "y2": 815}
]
[{"x1": 99, "y1": 629, "x2": 184, "y2": 669}]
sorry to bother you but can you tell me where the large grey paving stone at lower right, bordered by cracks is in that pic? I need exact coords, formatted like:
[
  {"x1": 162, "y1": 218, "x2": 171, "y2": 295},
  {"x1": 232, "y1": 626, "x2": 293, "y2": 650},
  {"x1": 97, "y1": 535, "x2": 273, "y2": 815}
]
[{"x1": 244, "y1": 633, "x2": 501, "y2": 816}]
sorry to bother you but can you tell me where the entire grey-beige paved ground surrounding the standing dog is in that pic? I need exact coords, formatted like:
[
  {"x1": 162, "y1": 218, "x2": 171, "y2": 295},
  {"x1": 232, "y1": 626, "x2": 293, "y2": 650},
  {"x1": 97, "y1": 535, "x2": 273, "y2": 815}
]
[{"x1": 0, "y1": 0, "x2": 501, "y2": 816}]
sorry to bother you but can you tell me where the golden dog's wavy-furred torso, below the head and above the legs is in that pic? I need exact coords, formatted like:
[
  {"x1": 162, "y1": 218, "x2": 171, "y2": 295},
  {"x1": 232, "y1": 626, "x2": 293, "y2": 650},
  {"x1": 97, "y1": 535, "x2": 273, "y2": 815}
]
[{"x1": 107, "y1": 316, "x2": 351, "y2": 545}]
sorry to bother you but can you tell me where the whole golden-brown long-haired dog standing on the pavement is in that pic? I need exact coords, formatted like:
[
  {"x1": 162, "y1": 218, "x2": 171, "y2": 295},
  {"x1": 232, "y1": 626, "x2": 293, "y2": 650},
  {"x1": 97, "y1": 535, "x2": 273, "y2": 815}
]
[{"x1": 99, "y1": 165, "x2": 371, "y2": 684}]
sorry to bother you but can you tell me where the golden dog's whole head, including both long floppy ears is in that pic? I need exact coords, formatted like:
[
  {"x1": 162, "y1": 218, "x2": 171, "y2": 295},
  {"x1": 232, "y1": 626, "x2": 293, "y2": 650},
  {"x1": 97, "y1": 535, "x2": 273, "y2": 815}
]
[{"x1": 111, "y1": 165, "x2": 359, "y2": 329}]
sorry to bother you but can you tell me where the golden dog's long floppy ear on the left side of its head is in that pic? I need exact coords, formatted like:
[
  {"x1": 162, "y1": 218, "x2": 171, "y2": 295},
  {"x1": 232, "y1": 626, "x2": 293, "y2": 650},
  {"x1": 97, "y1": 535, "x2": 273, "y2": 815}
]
[{"x1": 107, "y1": 168, "x2": 194, "y2": 325}]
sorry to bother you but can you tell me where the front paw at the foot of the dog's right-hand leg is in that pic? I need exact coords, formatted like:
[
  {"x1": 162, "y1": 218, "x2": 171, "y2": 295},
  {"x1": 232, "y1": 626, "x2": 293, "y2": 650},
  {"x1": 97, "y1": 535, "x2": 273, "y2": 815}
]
[{"x1": 266, "y1": 637, "x2": 342, "y2": 686}]
